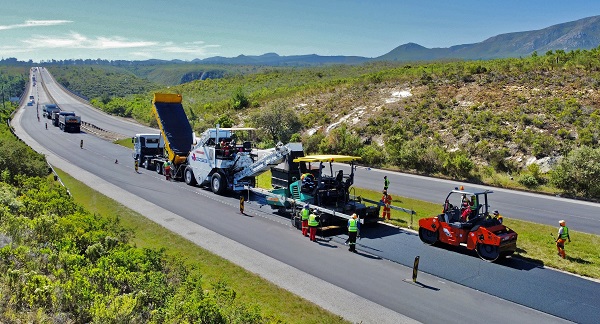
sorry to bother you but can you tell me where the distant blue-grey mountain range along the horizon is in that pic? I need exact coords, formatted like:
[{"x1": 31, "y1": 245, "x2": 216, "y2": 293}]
[{"x1": 193, "y1": 16, "x2": 600, "y2": 66}]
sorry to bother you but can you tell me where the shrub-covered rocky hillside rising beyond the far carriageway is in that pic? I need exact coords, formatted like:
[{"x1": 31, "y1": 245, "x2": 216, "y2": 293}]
[{"x1": 50, "y1": 49, "x2": 600, "y2": 199}]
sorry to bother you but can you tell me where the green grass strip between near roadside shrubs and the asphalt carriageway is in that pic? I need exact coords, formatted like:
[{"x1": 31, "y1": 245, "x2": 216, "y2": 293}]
[{"x1": 55, "y1": 169, "x2": 346, "y2": 323}]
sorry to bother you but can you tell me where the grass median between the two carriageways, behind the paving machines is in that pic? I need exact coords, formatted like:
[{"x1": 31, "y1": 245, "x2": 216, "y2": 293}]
[{"x1": 258, "y1": 172, "x2": 600, "y2": 279}]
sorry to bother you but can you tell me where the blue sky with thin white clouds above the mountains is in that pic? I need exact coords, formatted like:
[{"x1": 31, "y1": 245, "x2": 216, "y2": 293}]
[{"x1": 0, "y1": 0, "x2": 600, "y2": 62}]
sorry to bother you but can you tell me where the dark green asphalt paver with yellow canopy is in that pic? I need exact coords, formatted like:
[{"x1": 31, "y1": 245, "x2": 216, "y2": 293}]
[{"x1": 266, "y1": 155, "x2": 380, "y2": 235}]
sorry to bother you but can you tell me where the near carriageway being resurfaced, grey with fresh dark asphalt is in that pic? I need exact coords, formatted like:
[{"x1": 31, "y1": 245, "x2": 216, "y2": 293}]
[{"x1": 15, "y1": 67, "x2": 600, "y2": 323}]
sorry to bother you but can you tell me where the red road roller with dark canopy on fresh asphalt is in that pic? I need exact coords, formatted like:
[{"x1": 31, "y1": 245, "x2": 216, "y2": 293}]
[{"x1": 419, "y1": 187, "x2": 517, "y2": 262}]
